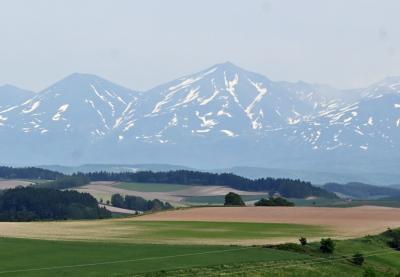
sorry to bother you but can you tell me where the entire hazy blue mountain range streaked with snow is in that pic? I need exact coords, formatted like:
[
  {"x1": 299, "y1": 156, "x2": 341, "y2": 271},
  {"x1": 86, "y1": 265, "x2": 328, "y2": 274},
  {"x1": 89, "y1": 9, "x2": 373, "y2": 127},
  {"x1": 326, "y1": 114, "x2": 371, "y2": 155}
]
[{"x1": 0, "y1": 62, "x2": 400, "y2": 183}]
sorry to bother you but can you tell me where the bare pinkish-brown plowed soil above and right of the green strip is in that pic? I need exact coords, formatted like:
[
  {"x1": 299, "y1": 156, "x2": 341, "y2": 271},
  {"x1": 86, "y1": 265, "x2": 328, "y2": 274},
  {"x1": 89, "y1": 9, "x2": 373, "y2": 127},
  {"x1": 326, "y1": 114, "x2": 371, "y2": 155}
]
[{"x1": 135, "y1": 206, "x2": 400, "y2": 237}]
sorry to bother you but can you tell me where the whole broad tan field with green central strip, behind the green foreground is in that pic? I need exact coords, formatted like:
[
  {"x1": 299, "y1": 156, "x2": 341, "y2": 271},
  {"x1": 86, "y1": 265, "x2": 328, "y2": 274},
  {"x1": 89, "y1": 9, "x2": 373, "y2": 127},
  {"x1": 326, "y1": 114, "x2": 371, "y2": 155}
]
[{"x1": 0, "y1": 206, "x2": 400, "y2": 245}]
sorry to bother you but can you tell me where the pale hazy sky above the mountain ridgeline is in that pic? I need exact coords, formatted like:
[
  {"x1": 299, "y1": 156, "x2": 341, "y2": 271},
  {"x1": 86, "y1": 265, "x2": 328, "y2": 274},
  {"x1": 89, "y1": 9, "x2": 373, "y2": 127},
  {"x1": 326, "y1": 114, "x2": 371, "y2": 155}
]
[{"x1": 0, "y1": 0, "x2": 400, "y2": 90}]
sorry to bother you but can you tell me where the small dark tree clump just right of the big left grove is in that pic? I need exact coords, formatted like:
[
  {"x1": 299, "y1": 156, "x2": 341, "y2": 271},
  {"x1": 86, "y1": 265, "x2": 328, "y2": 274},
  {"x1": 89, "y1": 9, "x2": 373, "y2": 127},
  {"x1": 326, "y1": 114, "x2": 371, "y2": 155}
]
[{"x1": 111, "y1": 194, "x2": 173, "y2": 212}]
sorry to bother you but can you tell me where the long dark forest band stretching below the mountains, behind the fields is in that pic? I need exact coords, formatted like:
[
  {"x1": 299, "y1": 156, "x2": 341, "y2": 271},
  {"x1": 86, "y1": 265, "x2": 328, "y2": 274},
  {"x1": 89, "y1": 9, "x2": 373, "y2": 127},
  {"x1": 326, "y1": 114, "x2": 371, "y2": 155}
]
[{"x1": 0, "y1": 167, "x2": 336, "y2": 198}]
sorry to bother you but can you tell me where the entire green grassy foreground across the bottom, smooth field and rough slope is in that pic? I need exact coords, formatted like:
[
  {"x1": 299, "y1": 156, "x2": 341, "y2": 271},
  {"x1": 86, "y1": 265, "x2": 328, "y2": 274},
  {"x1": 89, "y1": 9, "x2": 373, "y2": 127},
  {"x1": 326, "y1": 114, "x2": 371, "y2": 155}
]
[{"x1": 0, "y1": 230, "x2": 400, "y2": 277}]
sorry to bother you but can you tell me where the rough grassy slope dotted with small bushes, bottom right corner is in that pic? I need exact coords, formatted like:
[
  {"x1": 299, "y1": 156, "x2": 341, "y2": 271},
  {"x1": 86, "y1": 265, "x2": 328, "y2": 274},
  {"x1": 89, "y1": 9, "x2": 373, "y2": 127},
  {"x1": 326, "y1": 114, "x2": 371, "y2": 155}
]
[{"x1": 150, "y1": 232, "x2": 400, "y2": 277}]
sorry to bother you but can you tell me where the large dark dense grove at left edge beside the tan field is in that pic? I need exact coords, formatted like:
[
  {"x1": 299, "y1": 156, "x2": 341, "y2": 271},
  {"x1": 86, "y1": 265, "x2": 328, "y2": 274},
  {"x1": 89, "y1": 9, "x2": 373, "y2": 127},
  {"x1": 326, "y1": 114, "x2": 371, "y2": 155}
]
[{"x1": 0, "y1": 187, "x2": 111, "y2": 221}]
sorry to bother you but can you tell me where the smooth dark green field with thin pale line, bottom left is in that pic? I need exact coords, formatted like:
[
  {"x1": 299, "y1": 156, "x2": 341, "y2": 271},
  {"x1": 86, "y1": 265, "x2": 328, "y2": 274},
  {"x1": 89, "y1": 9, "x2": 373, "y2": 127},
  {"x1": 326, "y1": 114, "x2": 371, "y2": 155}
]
[{"x1": 0, "y1": 238, "x2": 309, "y2": 276}]
